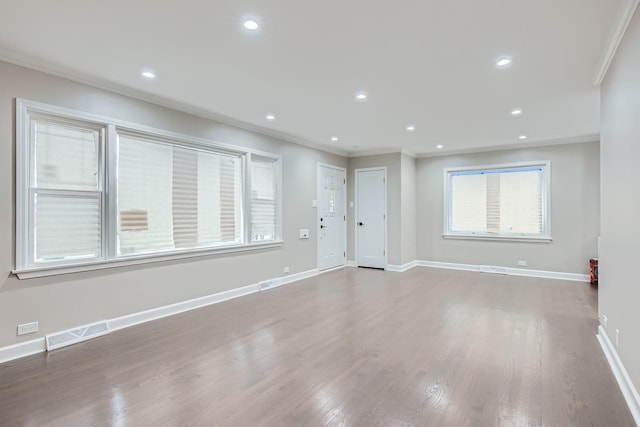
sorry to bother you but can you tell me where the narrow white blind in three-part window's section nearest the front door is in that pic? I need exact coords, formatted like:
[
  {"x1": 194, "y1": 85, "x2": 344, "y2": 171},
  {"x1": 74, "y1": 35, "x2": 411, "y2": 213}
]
[{"x1": 251, "y1": 157, "x2": 278, "y2": 242}]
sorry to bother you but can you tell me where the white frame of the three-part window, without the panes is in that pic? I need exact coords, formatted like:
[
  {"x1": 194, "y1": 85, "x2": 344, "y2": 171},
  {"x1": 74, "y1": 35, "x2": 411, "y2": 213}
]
[{"x1": 12, "y1": 99, "x2": 283, "y2": 279}]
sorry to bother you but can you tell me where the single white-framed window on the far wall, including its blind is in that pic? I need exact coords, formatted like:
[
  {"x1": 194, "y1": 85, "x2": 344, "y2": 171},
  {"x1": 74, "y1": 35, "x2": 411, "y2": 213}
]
[{"x1": 444, "y1": 162, "x2": 551, "y2": 241}]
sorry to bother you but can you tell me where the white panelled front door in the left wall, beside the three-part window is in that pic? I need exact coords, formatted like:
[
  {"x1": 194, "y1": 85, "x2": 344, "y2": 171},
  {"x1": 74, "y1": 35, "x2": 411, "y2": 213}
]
[{"x1": 317, "y1": 165, "x2": 347, "y2": 270}]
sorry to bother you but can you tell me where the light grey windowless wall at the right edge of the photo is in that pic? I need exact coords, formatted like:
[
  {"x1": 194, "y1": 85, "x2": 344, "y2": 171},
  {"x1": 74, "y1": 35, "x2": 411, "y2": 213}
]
[{"x1": 598, "y1": 9, "x2": 640, "y2": 389}]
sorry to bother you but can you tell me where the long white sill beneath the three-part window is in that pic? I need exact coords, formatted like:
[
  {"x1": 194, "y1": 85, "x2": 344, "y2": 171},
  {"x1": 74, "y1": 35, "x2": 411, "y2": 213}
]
[{"x1": 11, "y1": 241, "x2": 284, "y2": 279}]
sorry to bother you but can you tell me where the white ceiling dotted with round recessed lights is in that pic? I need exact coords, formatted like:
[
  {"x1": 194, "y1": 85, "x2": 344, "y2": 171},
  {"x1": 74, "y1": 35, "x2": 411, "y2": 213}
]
[{"x1": 0, "y1": 0, "x2": 626, "y2": 155}]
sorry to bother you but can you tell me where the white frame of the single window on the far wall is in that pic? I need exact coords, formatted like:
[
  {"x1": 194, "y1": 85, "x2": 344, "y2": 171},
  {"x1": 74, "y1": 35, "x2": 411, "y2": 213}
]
[{"x1": 442, "y1": 160, "x2": 553, "y2": 243}]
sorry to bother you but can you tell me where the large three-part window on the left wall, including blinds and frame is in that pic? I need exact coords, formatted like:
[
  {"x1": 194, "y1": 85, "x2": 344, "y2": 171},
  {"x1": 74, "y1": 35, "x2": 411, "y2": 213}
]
[{"x1": 16, "y1": 100, "x2": 281, "y2": 277}]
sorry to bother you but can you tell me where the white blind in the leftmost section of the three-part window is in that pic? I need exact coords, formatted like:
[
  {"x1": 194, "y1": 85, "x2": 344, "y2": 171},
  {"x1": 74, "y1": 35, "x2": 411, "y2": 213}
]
[{"x1": 30, "y1": 118, "x2": 102, "y2": 264}]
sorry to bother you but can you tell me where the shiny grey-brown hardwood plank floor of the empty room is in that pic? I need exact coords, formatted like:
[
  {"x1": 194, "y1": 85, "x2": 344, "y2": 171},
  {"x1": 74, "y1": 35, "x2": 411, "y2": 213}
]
[{"x1": 0, "y1": 268, "x2": 634, "y2": 427}]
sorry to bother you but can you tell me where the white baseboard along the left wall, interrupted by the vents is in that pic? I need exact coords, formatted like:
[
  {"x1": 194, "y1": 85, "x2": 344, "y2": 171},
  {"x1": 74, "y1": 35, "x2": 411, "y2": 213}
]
[{"x1": 0, "y1": 269, "x2": 318, "y2": 363}]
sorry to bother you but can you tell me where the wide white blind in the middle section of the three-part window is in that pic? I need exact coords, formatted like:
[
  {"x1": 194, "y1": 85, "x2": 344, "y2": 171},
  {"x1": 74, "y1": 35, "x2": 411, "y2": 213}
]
[{"x1": 118, "y1": 133, "x2": 243, "y2": 255}]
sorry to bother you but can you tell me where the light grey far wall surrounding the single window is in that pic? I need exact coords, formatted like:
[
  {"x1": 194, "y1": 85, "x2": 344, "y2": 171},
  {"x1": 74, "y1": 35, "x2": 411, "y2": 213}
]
[{"x1": 416, "y1": 142, "x2": 600, "y2": 274}]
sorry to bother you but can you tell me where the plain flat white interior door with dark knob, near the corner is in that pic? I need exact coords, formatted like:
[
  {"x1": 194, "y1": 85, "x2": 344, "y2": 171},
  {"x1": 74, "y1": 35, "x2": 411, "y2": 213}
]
[{"x1": 356, "y1": 168, "x2": 387, "y2": 268}]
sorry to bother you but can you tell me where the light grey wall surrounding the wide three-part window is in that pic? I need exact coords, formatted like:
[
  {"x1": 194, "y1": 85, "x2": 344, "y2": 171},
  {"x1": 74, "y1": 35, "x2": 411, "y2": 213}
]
[{"x1": 0, "y1": 62, "x2": 347, "y2": 347}]
